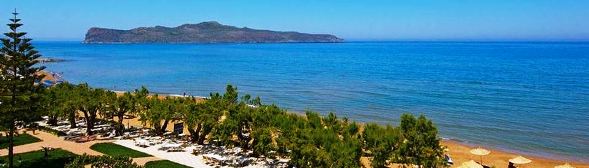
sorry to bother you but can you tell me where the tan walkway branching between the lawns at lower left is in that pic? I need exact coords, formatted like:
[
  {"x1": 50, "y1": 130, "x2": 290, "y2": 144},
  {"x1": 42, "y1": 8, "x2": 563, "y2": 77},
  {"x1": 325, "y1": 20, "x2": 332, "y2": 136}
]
[{"x1": 0, "y1": 131, "x2": 162, "y2": 165}]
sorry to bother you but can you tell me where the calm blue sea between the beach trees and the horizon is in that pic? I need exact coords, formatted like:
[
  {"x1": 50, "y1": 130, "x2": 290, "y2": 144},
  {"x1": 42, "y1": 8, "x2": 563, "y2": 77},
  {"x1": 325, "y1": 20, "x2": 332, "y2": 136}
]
[{"x1": 35, "y1": 42, "x2": 589, "y2": 161}]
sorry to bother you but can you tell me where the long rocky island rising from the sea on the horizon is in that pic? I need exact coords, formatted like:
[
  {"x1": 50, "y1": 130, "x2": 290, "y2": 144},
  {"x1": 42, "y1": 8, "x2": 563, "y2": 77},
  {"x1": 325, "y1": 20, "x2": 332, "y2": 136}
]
[{"x1": 84, "y1": 21, "x2": 343, "y2": 43}]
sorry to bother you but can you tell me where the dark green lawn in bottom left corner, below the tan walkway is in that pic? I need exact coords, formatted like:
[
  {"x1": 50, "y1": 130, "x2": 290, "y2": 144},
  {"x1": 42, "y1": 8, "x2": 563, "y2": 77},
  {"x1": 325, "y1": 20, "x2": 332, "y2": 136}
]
[{"x1": 0, "y1": 149, "x2": 78, "y2": 168}]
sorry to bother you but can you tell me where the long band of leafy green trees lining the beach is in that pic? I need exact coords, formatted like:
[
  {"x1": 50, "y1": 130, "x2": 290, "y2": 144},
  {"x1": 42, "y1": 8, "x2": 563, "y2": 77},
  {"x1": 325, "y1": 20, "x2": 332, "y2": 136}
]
[{"x1": 45, "y1": 83, "x2": 445, "y2": 167}]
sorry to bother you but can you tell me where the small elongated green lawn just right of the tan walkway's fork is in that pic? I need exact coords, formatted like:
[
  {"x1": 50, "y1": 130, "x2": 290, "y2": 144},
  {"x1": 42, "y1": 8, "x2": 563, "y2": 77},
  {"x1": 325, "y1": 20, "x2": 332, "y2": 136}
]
[{"x1": 90, "y1": 142, "x2": 151, "y2": 158}]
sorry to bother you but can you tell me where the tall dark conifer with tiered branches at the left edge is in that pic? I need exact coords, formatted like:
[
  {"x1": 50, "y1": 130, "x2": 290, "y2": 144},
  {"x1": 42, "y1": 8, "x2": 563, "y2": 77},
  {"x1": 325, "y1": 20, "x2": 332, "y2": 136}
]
[{"x1": 0, "y1": 10, "x2": 44, "y2": 167}]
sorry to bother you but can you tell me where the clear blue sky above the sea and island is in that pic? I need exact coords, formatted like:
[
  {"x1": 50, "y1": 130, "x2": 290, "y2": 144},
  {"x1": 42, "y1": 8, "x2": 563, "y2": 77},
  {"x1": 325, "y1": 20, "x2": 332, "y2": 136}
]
[{"x1": 0, "y1": 0, "x2": 589, "y2": 41}]
